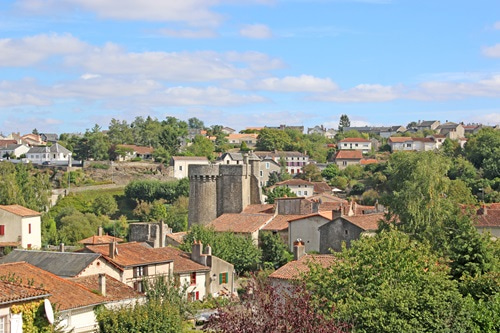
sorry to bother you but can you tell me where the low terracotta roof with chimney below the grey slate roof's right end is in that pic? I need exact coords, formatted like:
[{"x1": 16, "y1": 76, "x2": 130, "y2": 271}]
[{"x1": 70, "y1": 274, "x2": 144, "y2": 302}]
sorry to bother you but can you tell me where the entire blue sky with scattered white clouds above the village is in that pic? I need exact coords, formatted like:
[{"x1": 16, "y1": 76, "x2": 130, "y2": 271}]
[{"x1": 0, "y1": 0, "x2": 500, "y2": 134}]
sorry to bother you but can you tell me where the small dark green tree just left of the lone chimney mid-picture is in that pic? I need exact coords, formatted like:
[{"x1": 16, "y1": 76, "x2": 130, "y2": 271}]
[{"x1": 259, "y1": 231, "x2": 292, "y2": 269}]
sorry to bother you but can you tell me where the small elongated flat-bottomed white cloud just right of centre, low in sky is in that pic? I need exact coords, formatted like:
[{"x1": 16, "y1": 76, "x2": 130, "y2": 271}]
[{"x1": 256, "y1": 75, "x2": 338, "y2": 93}]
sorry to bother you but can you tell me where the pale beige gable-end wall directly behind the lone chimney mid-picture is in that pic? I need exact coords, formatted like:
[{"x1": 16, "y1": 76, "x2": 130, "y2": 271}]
[{"x1": 288, "y1": 214, "x2": 330, "y2": 252}]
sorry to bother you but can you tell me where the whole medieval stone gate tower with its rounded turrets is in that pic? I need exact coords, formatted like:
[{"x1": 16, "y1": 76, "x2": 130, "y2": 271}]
[{"x1": 188, "y1": 155, "x2": 261, "y2": 226}]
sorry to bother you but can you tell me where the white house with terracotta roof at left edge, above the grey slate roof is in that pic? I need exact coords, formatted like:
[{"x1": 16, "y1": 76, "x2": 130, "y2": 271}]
[{"x1": 0, "y1": 205, "x2": 42, "y2": 249}]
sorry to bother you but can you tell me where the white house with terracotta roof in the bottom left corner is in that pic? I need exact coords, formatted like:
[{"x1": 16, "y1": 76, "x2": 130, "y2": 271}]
[{"x1": 0, "y1": 279, "x2": 50, "y2": 333}]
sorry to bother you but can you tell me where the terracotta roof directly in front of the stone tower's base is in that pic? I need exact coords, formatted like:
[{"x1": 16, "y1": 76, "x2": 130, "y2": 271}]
[{"x1": 208, "y1": 213, "x2": 272, "y2": 233}]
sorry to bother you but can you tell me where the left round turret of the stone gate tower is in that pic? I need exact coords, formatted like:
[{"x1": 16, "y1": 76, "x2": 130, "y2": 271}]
[{"x1": 188, "y1": 165, "x2": 219, "y2": 227}]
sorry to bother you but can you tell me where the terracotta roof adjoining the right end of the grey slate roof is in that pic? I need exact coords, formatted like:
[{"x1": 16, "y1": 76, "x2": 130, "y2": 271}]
[{"x1": 86, "y1": 242, "x2": 172, "y2": 269}]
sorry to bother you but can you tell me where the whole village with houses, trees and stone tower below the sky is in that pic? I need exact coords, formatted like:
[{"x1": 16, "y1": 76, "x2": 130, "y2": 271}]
[{"x1": 0, "y1": 115, "x2": 500, "y2": 332}]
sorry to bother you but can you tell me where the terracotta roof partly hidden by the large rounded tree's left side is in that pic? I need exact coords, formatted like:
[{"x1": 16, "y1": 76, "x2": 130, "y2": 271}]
[{"x1": 269, "y1": 254, "x2": 336, "y2": 280}]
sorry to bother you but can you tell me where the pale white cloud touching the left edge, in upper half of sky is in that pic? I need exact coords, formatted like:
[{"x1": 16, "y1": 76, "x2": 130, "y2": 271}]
[{"x1": 0, "y1": 34, "x2": 88, "y2": 67}]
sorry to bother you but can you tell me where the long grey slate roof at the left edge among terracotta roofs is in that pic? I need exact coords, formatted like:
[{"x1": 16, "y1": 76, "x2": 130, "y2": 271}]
[{"x1": 0, "y1": 249, "x2": 101, "y2": 277}]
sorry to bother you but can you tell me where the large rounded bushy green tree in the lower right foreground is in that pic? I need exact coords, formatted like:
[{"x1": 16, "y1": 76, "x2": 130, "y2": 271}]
[{"x1": 305, "y1": 231, "x2": 474, "y2": 333}]
